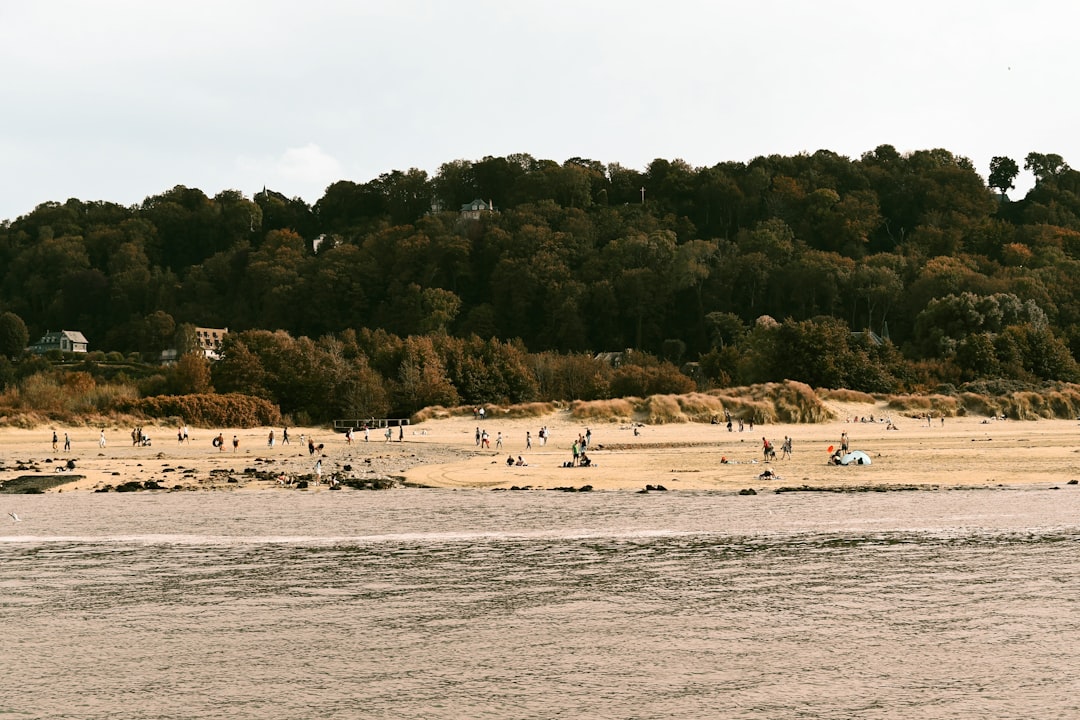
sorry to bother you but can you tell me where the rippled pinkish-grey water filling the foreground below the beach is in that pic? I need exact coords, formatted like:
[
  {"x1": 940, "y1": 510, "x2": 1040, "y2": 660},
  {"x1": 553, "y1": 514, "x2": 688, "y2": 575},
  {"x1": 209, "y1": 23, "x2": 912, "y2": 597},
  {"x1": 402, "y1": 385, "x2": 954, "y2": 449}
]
[{"x1": 0, "y1": 486, "x2": 1080, "y2": 719}]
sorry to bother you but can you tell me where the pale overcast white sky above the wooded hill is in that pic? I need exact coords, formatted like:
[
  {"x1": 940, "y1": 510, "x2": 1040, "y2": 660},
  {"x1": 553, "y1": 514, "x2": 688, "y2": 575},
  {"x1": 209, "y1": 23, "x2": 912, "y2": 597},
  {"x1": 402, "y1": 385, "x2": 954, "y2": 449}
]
[{"x1": 0, "y1": 0, "x2": 1080, "y2": 220}]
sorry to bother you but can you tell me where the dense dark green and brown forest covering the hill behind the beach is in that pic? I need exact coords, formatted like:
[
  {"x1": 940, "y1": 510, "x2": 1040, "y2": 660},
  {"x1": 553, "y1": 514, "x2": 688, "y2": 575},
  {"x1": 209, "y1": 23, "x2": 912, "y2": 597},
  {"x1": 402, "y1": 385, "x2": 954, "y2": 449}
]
[{"x1": 0, "y1": 146, "x2": 1080, "y2": 420}]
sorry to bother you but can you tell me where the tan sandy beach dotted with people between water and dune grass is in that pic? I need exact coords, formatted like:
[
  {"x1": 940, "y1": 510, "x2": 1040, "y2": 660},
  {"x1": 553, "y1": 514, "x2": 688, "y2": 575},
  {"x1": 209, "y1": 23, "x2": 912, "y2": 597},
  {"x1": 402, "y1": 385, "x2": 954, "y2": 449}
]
[{"x1": 0, "y1": 404, "x2": 1080, "y2": 492}]
